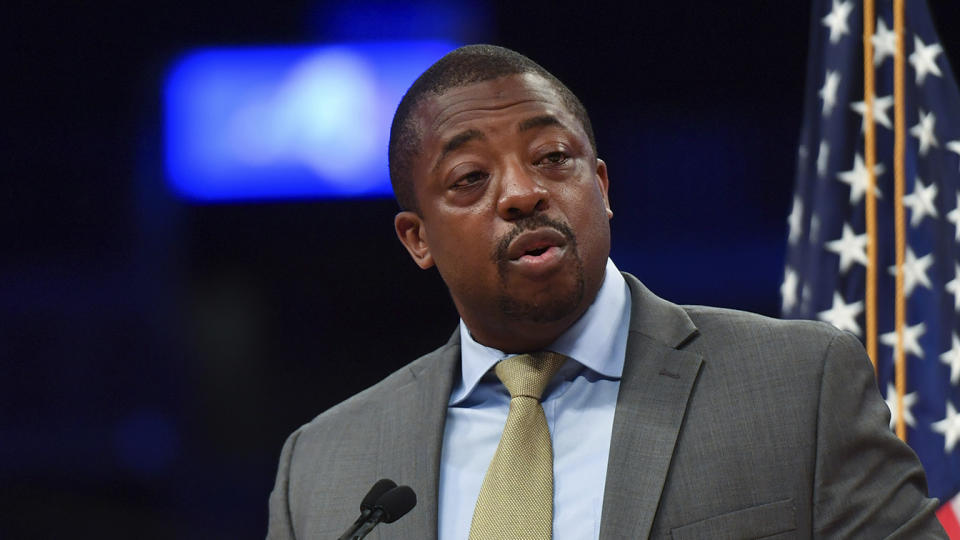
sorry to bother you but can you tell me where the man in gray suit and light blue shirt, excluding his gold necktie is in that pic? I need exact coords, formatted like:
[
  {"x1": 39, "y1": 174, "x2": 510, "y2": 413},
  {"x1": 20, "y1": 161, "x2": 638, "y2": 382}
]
[{"x1": 269, "y1": 46, "x2": 946, "y2": 539}]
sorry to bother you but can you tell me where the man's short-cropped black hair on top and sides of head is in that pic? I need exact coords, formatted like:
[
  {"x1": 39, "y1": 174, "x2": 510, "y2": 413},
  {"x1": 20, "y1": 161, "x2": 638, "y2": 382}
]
[{"x1": 388, "y1": 45, "x2": 597, "y2": 212}]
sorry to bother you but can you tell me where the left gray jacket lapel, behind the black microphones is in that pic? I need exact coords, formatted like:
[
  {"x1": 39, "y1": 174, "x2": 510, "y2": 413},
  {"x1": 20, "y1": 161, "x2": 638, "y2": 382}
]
[{"x1": 374, "y1": 338, "x2": 460, "y2": 539}]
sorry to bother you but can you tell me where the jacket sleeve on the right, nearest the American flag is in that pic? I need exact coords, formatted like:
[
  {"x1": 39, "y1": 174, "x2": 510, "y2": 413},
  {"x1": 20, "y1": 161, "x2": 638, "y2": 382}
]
[{"x1": 813, "y1": 333, "x2": 947, "y2": 539}]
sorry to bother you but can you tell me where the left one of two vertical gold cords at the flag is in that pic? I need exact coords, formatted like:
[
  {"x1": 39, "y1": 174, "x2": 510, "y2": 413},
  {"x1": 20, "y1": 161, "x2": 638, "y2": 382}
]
[{"x1": 863, "y1": 0, "x2": 877, "y2": 373}]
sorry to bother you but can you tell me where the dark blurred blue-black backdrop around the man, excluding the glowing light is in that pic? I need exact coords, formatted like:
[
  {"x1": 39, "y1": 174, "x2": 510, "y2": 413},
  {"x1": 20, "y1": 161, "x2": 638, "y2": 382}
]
[{"x1": 0, "y1": 0, "x2": 957, "y2": 538}]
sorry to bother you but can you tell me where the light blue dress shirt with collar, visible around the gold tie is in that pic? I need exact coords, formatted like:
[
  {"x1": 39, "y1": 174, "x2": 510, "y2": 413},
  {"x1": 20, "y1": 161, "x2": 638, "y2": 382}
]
[{"x1": 438, "y1": 259, "x2": 630, "y2": 540}]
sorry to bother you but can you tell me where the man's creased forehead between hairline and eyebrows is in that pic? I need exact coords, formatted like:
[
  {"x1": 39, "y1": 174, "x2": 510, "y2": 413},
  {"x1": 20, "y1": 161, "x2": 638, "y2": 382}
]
[{"x1": 416, "y1": 73, "x2": 578, "y2": 148}]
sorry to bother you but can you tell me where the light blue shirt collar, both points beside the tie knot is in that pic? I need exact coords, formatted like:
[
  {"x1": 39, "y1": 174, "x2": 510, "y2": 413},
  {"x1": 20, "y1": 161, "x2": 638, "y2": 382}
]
[{"x1": 450, "y1": 258, "x2": 630, "y2": 405}]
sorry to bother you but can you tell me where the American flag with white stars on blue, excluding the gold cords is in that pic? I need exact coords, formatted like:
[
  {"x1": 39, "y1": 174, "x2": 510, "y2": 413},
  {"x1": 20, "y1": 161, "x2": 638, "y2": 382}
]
[{"x1": 780, "y1": 0, "x2": 960, "y2": 538}]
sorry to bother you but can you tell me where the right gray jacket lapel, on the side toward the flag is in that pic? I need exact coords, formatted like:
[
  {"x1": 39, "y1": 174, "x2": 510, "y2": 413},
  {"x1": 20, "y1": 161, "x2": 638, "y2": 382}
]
[{"x1": 600, "y1": 274, "x2": 702, "y2": 539}]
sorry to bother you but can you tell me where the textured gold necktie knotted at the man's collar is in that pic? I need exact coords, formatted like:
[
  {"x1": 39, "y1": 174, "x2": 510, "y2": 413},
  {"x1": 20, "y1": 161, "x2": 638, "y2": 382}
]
[{"x1": 470, "y1": 352, "x2": 566, "y2": 540}]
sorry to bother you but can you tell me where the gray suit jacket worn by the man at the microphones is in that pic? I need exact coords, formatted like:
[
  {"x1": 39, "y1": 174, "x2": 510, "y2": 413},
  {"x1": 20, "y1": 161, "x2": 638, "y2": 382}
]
[{"x1": 268, "y1": 274, "x2": 946, "y2": 540}]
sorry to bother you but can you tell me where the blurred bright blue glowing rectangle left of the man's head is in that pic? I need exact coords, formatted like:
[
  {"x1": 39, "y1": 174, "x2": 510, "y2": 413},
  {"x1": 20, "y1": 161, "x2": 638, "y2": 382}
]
[{"x1": 164, "y1": 41, "x2": 455, "y2": 202}]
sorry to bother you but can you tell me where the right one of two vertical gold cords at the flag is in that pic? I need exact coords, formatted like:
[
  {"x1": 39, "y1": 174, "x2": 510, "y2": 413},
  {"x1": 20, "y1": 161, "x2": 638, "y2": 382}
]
[{"x1": 893, "y1": 0, "x2": 907, "y2": 441}]
